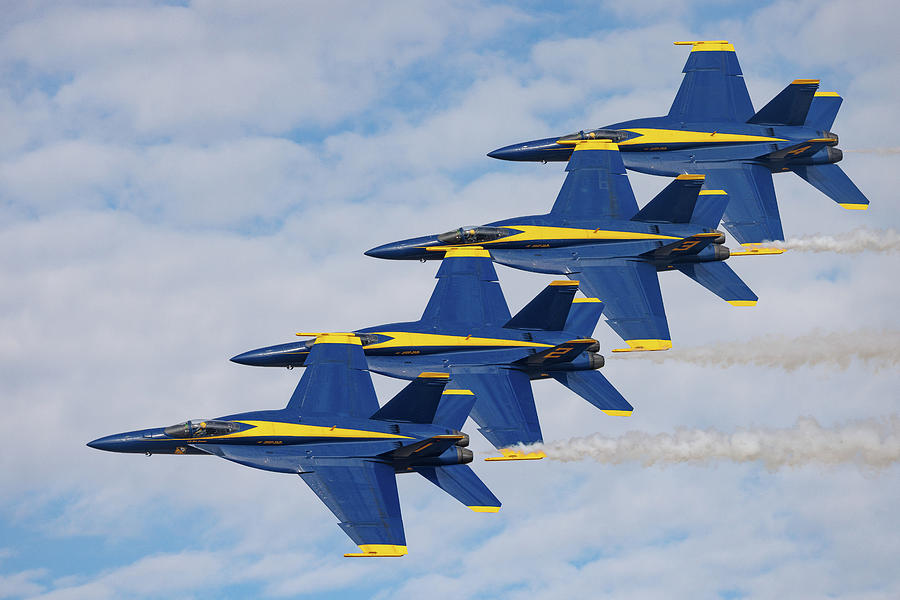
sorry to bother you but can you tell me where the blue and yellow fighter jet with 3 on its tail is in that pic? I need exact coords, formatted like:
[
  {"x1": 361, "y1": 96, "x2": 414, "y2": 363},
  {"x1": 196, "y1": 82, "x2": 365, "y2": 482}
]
[{"x1": 366, "y1": 140, "x2": 782, "y2": 352}]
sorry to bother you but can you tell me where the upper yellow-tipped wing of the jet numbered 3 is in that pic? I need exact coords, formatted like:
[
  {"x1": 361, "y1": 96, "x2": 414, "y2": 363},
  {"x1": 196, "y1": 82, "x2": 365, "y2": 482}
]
[{"x1": 550, "y1": 140, "x2": 638, "y2": 222}]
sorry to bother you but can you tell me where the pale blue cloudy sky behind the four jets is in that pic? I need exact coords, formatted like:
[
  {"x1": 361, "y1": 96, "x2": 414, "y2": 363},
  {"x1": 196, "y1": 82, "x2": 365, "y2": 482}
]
[{"x1": 0, "y1": 0, "x2": 900, "y2": 600}]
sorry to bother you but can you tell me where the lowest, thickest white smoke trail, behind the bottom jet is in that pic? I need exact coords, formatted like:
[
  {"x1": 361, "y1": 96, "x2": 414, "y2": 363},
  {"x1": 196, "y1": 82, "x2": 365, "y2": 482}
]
[{"x1": 525, "y1": 415, "x2": 900, "y2": 470}]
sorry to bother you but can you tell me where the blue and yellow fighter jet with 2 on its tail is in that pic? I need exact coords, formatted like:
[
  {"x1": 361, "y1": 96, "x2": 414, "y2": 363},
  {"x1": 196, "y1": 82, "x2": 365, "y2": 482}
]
[{"x1": 231, "y1": 248, "x2": 632, "y2": 460}]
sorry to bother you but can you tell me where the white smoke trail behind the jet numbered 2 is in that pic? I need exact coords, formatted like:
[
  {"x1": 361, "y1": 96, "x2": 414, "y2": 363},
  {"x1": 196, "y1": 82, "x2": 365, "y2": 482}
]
[{"x1": 609, "y1": 330, "x2": 900, "y2": 371}]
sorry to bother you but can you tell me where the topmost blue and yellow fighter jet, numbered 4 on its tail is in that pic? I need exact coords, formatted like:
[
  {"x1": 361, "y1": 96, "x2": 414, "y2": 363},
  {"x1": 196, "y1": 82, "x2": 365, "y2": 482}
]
[{"x1": 488, "y1": 41, "x2": 869, "y2": 244}]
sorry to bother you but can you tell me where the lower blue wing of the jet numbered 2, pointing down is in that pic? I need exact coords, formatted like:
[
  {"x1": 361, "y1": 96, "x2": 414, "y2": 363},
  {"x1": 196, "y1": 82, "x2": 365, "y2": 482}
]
[{"x1": 450, "y1": 366, "x2": 543, "y2": 449}]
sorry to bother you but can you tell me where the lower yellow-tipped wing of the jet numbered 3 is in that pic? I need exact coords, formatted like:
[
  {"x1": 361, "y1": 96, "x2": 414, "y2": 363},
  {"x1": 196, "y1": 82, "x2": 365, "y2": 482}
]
[{"x1": 568, "y1": 260, "x2": 672, "y2": 352}]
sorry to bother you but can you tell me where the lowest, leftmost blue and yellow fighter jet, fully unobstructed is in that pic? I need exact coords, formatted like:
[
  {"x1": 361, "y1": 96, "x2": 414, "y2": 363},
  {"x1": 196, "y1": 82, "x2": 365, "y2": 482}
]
[{"x1": 88, "y1": 335, "x2": 500, "y2": 556}]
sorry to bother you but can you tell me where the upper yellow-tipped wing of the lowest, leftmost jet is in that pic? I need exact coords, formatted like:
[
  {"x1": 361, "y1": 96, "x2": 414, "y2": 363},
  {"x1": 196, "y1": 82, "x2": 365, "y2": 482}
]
[{"x1": 287, "y1": 334, "x2": 378, "y2": 418}]
